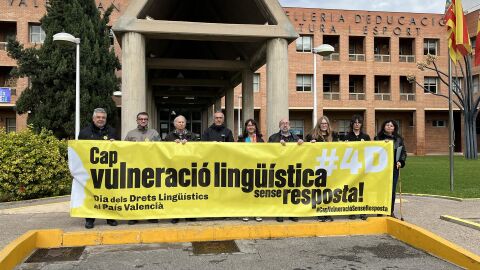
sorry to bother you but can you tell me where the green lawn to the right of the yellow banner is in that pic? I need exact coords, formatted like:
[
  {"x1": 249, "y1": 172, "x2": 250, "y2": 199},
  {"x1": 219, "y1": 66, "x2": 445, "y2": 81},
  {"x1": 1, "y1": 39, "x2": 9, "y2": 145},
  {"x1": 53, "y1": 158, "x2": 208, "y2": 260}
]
[{"x1": 397, "y1": 156, "x2": 480, "y2": 198}]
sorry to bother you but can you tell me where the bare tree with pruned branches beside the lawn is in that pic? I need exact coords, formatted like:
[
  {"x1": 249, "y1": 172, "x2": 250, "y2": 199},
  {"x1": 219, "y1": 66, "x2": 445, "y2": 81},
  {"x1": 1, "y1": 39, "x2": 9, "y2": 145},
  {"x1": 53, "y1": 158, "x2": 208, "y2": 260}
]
[{"x1": 407, "y1": 54, "x2": 480, "y2": 159}]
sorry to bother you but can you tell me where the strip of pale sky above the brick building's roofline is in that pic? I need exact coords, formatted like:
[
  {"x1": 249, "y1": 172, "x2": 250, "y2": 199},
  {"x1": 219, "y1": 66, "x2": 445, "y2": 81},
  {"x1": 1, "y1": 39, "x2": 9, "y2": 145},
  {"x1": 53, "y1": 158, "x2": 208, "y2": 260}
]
[{"x1": 279, "y1": 0, "x2": 480, "y2": 13}]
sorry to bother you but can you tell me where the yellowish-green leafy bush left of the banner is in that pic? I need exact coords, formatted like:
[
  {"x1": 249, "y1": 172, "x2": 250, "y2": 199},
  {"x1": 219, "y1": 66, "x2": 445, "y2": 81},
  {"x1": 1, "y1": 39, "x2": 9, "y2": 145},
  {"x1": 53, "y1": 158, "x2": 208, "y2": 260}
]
[{"x1": 0, "y1": 128, "x2": 72, "y2": 201}]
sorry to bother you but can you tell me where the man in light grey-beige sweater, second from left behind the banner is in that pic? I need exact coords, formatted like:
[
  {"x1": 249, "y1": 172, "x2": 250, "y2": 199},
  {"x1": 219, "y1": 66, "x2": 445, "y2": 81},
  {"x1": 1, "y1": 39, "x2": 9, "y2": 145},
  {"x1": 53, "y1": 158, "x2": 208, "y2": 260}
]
[{"x1": 124, "y1": 112, "x2": 160, "y2": 225}]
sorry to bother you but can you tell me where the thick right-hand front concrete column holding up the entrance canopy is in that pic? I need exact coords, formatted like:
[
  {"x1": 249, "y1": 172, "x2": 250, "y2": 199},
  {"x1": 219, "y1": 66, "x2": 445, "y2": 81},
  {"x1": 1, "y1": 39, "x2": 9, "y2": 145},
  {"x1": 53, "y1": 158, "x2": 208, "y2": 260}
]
[{"x1": 267, "y1": 38, "x2": 288, "y2": 135}]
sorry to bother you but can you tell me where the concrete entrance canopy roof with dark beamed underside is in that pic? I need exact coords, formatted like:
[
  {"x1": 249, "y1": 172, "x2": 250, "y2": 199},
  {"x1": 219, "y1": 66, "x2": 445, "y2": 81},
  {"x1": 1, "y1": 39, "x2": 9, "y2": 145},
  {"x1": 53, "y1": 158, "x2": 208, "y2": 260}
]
[{"x1": 113, "y1": 0, "x2": 298, "y2": 108}]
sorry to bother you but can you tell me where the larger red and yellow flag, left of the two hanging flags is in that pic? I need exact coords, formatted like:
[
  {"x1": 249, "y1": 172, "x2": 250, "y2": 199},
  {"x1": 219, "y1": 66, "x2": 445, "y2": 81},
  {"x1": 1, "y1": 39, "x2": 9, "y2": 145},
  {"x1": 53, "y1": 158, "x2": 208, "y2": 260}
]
[{"x1": 445, "y1": 0, "x2": 472, "y2": 62}]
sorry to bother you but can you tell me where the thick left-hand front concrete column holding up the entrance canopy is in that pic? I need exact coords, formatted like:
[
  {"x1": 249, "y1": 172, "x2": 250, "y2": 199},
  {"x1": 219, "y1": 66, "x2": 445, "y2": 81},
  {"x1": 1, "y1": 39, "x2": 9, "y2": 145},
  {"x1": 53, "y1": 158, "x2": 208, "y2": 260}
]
[{"x1": 121, "y1": 32, "x2": 147, "y2": 138}]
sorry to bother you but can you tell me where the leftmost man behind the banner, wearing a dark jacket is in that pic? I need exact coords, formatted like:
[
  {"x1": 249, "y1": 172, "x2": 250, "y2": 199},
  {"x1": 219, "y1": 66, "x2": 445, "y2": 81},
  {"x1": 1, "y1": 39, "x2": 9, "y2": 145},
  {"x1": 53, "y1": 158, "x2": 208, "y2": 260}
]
[{"x1": 78, "y1": 108, "x2": 119, "y2": 229}]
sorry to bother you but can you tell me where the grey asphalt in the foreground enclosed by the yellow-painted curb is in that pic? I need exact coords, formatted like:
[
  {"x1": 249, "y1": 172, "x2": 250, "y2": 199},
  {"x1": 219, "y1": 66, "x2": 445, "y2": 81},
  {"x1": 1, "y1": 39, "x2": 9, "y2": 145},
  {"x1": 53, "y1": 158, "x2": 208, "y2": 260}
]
[{"x1": 17, "y1": 235, "x2": 460, "y2": 270}]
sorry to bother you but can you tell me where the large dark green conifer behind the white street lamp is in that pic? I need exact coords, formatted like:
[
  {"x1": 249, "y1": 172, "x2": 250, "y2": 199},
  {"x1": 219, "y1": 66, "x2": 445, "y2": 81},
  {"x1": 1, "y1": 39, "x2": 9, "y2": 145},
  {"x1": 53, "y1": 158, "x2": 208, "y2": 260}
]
[{"x1": 7, "y1": 0, "x2": 120, "y2": 138}]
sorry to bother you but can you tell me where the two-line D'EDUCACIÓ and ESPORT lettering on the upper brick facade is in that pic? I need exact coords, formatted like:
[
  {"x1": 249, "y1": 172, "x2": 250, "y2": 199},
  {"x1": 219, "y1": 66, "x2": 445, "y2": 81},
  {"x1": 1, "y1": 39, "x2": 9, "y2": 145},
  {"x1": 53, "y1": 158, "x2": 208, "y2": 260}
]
[{"x1": 285, "y1": 10, "x2": 445, "y2": 36}]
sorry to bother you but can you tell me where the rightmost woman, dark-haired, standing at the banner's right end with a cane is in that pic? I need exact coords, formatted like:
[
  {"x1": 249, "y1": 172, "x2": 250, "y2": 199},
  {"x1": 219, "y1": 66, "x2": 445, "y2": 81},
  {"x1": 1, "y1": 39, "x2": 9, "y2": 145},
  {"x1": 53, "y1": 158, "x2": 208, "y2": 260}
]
[{"x1": 375, "y1": 120, "x2": 407, "y2": 217}]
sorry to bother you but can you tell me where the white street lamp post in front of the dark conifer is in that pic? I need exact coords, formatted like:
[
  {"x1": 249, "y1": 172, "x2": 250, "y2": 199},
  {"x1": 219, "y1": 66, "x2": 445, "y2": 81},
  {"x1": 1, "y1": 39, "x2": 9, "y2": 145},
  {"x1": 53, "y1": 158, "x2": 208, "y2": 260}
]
[{"x1": 53, "y1": 32, "x2": 80, "y2": 140}]
